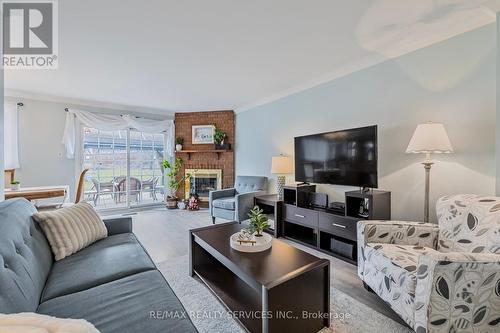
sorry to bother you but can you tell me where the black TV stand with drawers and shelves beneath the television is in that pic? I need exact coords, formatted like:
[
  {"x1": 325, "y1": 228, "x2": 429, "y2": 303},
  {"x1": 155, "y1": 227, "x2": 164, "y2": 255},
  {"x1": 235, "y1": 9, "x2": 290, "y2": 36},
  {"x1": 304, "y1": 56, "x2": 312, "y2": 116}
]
[{"x1": 281, "y1": 185, "x2": 391, "y2": 264}]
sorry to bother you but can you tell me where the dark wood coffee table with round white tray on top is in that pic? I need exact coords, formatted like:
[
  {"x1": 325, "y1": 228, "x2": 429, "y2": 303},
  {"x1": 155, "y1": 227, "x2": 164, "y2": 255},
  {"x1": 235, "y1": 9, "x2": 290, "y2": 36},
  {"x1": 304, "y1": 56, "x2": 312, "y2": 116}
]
[{"x1": 189, "y1": 222, "x2": 330, "y2": 333}]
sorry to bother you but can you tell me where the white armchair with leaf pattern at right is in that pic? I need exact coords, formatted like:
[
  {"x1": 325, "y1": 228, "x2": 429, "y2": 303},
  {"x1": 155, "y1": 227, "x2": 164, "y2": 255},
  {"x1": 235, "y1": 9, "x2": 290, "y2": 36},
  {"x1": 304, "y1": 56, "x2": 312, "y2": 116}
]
[{"x1": 357, "y1": 195, "x2": 500, "y2": 333}]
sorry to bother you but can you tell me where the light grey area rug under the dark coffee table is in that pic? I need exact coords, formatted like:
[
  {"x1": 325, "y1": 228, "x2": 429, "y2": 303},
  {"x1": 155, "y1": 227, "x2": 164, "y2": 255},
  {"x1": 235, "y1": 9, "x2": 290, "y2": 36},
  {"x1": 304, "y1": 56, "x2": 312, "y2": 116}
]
[{"x1": 158, "y1": 255, "x2": 413, "y2": 333}]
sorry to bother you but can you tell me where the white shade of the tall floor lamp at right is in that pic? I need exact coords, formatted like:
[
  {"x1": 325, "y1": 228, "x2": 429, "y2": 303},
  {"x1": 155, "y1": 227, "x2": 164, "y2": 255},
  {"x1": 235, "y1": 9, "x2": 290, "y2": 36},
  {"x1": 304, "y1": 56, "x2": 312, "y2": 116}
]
[{"x1": 406, "y1": 122, "x2": 453, "y2": 154}]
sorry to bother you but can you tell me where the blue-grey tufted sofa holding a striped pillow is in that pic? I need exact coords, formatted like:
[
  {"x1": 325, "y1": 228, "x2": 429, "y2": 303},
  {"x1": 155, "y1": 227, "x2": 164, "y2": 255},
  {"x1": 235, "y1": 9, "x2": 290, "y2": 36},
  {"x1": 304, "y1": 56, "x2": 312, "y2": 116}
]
[{"x1": 0, "y1": 199, "x2": 197, "y2": 333}]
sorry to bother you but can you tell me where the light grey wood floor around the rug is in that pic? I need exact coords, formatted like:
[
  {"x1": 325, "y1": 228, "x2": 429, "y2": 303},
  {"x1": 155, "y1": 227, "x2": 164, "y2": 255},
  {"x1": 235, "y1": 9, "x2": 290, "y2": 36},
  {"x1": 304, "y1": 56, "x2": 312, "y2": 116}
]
[{"x1": 124, "y1": 208, "x2": 404, "y2": 324}]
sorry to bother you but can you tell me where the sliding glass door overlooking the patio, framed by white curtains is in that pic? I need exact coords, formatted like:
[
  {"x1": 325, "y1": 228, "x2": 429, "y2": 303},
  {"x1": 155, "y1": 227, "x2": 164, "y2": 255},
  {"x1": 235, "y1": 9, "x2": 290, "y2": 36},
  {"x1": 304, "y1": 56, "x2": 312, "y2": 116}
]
[{"x1": 82, "y1": 127, "x2": 165, "y2": 209}]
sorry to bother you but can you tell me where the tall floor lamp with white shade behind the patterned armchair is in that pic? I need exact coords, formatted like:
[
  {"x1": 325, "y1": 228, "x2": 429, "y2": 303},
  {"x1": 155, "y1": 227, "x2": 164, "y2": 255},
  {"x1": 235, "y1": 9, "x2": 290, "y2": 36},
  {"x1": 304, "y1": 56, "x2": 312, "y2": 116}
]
[{"x1": 406, "y1": 122, "x2": 453, "y2": 222}]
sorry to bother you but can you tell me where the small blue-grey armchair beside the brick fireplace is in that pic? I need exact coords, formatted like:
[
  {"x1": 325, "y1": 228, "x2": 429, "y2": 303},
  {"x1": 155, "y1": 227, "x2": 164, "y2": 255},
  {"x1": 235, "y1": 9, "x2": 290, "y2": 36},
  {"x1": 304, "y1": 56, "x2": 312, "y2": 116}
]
[{"x1": 208, "y1": 176, "x2": 267, "y2": 224}]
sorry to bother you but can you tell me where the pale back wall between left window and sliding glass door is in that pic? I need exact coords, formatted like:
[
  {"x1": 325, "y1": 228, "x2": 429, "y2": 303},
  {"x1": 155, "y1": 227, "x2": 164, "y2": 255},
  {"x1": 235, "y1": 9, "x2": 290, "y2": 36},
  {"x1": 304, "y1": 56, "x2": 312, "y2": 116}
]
[{"x1": 2, "y1": 97, "x2": 174, "y2": 199}]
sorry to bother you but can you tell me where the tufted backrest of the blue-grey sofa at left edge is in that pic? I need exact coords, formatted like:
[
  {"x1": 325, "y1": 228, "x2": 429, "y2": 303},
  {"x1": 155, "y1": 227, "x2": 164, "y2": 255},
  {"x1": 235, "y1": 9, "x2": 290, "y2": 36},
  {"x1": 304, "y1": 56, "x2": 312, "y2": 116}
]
[{"x1": 0, "y1": 199, "x2": 53, "y2": 313}]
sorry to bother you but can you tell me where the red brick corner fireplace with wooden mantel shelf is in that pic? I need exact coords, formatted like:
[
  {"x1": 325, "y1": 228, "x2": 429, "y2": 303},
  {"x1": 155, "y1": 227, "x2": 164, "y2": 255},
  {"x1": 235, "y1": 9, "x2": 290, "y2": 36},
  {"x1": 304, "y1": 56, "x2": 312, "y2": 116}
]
[{"x1": 175, "y1": 111, "x2": 234, "y2": 201}]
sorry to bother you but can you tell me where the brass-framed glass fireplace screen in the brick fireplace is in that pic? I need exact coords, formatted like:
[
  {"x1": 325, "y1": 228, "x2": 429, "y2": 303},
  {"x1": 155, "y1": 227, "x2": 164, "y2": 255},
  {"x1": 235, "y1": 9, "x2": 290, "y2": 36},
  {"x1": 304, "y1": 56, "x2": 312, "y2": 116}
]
[{"x1": 184, "y1": 169, "x2": 222, "y2": 201}]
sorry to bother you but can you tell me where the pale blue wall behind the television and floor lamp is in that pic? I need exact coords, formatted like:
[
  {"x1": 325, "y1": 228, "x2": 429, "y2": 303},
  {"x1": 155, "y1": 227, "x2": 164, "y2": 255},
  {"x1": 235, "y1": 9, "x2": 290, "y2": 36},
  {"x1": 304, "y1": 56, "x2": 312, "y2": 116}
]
[{"x1": 235, "y1": 24, "x2": 496, "y2": 220}]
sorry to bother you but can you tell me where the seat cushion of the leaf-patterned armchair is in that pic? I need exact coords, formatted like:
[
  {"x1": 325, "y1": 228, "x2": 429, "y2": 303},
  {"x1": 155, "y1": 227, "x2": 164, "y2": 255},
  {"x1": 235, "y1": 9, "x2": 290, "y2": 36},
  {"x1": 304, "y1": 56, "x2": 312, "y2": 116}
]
[{"x1": 364, "y1": 243, "x2": 435, "y2": 295}]
